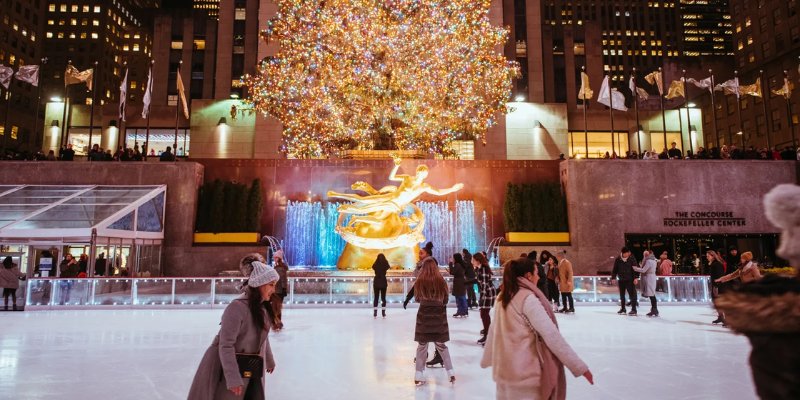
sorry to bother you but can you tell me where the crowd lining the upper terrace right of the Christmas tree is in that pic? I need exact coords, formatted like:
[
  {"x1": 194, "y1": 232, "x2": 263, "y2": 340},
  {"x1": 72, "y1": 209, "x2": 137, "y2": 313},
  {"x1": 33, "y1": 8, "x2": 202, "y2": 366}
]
[{"x1": 603, "y1": 142, "x2": 800, "y2": 160}]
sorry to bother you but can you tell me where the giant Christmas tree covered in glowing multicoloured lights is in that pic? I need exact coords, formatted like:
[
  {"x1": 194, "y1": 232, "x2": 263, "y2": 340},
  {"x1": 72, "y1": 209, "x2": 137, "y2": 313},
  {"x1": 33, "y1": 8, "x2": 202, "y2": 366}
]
[{"x1": 245, "y1": 0, "x2": 517, "y2": 158}]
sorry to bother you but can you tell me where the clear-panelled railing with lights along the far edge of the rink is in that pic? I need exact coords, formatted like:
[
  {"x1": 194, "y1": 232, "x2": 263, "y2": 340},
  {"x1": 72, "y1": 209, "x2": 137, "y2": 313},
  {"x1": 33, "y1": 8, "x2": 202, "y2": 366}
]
[{"x1": 25, "y1": 276, "x2": 710, "y2": 310}]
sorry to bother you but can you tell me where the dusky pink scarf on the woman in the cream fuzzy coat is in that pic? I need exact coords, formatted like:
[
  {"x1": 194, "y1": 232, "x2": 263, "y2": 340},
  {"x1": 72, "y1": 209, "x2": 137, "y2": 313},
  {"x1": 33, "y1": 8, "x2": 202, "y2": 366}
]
[{"x1": 514, "y1": 278, "x2": 567, "y2": 400}]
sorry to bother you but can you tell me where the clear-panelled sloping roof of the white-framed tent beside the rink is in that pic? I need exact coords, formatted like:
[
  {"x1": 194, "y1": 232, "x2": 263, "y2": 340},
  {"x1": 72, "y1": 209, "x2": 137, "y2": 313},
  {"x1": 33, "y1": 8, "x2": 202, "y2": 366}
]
[{"x1": 0, "y1": 185, "x2": 167, "y2": 242}]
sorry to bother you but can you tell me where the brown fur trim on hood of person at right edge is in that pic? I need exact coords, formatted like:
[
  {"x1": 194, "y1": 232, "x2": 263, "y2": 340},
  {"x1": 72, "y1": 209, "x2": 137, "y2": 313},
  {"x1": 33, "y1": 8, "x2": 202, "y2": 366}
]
[{"x1": 714, "y1": 275, "x2": 800, "y2": 333}]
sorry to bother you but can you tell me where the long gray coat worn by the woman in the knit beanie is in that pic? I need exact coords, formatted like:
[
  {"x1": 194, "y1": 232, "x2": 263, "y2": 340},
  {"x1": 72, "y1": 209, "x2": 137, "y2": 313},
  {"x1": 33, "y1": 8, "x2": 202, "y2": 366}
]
[{"x1": 188, "y1": 294, "x2": 275, "y2": 400}]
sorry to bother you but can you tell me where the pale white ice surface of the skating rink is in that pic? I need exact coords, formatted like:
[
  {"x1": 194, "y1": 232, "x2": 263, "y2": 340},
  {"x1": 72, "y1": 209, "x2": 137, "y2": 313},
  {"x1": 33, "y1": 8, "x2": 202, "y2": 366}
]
[{"x1": 0, "y1": 304, "x2": 756, "y2": 400}]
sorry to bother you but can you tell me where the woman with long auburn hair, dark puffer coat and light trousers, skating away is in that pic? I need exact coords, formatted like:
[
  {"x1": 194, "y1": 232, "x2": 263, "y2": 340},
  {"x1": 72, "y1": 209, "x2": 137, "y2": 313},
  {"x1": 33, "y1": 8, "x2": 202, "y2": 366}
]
[{"x1": 414, "y1": 259, "x2": 456, "y2": 385}]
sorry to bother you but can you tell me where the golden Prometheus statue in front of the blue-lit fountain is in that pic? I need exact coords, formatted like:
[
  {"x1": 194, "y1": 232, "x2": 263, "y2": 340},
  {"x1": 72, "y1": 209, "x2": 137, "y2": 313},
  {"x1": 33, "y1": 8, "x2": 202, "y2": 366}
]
[{"x1": 328, "y1": 157, "x2": 464, "y2": 269}]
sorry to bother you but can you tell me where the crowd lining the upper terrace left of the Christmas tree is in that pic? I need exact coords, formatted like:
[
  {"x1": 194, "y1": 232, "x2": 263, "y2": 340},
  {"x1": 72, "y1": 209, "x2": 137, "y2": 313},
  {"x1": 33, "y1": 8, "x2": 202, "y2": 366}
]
[{"x1": 3, "y1": 142, "x2": 183, "y2": 161}]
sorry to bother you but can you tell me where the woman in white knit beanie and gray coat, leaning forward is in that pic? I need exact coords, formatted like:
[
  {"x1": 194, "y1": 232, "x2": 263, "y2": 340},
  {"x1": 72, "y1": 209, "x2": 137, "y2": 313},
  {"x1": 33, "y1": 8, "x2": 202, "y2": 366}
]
[{"x1": 188, "y1": 261, "x2": 279, "y2": 400}]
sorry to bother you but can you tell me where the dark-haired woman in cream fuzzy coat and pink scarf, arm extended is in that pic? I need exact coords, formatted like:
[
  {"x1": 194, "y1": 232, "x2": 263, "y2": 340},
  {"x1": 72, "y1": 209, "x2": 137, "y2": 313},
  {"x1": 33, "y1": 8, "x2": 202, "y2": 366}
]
[{"x1": 481, "y1": 259, "x2": 594, "y2": 400}]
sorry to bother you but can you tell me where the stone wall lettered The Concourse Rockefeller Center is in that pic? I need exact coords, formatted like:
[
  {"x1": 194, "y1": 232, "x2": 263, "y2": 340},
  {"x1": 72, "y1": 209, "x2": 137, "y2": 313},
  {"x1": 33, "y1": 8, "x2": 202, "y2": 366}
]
[{"x1": 560, "y1": 160, "x2": 798, "y2": 274}]
